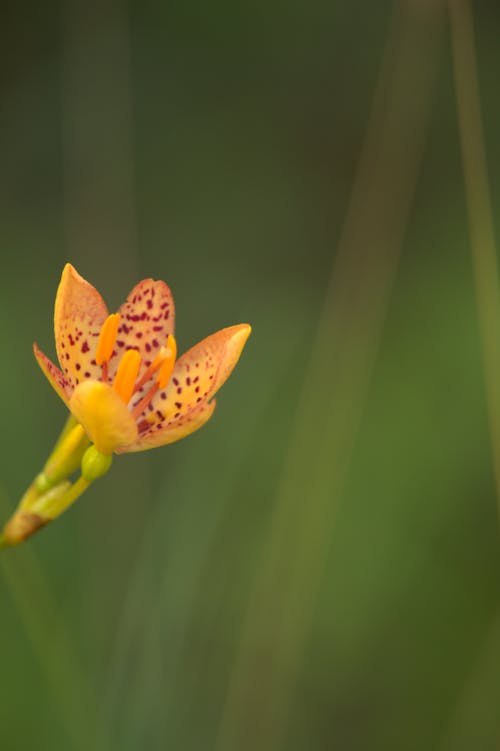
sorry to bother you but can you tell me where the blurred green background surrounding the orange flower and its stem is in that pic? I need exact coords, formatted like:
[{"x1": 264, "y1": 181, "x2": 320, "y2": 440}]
[{"x1": 0, "y1": 0, "x2": 500, "y2": 751}]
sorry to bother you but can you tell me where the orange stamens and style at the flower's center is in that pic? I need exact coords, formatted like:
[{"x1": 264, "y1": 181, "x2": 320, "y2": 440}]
[{"x1": 95, "y1": 313, "x2": 177, "y2": 420}]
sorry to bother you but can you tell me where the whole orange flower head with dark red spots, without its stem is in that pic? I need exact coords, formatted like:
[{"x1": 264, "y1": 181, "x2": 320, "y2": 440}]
[{"x1": 34, "y1": 263, "x2": 251, "y2": 455}]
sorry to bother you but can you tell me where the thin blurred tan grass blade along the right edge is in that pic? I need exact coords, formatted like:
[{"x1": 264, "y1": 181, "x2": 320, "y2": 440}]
[{"x1": 449, "y1": 0, "x2": 500, "y2": 518}]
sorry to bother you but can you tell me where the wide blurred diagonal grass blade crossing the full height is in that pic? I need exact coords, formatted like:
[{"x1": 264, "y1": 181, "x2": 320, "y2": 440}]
[{"x1": 216, "y1": 3, "x2": 442, "y2": 751}]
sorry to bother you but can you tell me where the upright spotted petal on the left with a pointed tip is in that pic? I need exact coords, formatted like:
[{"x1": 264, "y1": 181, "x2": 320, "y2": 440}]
[{"x1": 54, "y1": 263, "x2": 108, "y2": 387}]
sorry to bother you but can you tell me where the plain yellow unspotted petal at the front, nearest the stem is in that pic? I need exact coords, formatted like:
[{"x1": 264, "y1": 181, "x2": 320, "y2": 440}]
[{"x1": 69, "y1": 381, "x2": 137, "y2": 454}]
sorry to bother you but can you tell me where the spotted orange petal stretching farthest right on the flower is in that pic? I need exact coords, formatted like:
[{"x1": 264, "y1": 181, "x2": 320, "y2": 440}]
[{"x1": 127, "y1": 324, "x2": 251, "y2": 451}]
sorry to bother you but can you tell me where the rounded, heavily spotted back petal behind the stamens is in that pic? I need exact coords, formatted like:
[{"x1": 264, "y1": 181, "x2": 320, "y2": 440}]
[{"x1": 109, "y1": 279, "x2": 175, "y2": 378}]
